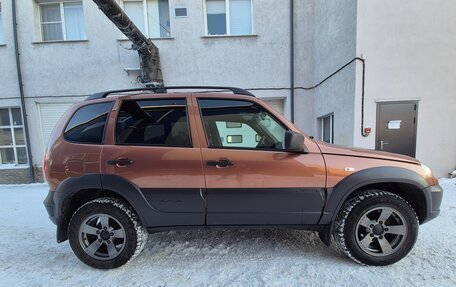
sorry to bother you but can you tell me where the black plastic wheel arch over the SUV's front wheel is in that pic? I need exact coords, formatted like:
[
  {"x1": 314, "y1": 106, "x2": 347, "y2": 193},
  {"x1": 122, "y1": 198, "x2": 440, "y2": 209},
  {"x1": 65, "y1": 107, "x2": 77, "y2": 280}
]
[{"x1": 319, "y1": 167, "x2": 430, "y2": 225}]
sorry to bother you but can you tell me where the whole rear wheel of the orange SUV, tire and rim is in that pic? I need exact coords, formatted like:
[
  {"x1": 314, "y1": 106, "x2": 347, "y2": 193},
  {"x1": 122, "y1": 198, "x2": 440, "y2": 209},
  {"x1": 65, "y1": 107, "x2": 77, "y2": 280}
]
[{"x1": 68, "y1": 198, "x2": 148, "y2": 269}]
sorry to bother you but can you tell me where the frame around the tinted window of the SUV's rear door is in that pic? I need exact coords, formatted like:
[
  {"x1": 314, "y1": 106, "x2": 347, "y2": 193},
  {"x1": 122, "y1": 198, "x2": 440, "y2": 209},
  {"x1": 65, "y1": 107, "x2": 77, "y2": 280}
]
[{"x1": 113, "y1": 97, "x2": 194, "y2": 148}]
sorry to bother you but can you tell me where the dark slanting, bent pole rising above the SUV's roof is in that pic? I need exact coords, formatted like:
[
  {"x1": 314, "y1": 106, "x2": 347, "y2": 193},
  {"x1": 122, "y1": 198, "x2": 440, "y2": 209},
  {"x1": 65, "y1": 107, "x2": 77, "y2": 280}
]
[{"x1": 93, "y1": 0, "x2": 163, "y2": 86}]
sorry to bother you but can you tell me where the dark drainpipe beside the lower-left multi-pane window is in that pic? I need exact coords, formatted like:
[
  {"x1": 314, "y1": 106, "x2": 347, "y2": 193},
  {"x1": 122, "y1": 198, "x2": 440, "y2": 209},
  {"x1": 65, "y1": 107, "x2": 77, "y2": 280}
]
[{"x1": 11, "y1": 0, "x2": 35, "y2": 182}]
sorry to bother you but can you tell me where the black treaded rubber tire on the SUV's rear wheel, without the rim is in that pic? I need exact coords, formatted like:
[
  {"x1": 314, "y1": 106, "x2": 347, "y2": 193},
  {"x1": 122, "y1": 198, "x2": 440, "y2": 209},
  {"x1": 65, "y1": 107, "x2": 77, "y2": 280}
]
[{"x1": 68, "y1": 197, "x2": 148, "y2": 269}]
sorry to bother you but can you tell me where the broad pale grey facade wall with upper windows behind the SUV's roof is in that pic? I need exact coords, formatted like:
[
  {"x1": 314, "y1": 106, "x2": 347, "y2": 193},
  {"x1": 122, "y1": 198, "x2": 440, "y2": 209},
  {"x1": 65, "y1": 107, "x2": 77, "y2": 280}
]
[{"x1": 0, "y1": 0, "x2": 302, "y2": 169}]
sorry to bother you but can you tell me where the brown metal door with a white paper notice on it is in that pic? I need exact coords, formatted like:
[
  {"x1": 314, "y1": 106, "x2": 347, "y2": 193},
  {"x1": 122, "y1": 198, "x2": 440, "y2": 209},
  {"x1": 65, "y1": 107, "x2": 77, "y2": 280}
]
[{"x1": 375, "y1": 101, "x2": 418, "y2": 157}]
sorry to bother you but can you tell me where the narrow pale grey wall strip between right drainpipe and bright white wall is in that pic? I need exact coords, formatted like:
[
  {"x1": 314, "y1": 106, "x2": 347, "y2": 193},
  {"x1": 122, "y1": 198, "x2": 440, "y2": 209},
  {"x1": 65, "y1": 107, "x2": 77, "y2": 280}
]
[{"x1": 314, "y1": 0, "x2": 357, "y2": 146}]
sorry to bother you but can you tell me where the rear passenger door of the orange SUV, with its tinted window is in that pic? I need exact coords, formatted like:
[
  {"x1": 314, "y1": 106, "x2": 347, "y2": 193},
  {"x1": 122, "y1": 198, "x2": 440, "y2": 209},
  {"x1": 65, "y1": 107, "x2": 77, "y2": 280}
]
[{"x1": 101, "y1": 95, "x2": 205, "y2": 226}]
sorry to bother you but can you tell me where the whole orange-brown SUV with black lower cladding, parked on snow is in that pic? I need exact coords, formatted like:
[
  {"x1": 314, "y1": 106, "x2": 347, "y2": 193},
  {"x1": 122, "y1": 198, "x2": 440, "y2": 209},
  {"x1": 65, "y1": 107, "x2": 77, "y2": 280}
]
[{"x1": 44, "y1": 87, "x2": 442, "y2": 269}]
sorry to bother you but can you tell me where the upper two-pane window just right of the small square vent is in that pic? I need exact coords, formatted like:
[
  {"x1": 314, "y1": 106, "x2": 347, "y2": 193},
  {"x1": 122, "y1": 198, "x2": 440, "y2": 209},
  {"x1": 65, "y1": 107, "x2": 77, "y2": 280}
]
[{"x1": 206, "y1": 0, "x2": 253, "y2": 35}]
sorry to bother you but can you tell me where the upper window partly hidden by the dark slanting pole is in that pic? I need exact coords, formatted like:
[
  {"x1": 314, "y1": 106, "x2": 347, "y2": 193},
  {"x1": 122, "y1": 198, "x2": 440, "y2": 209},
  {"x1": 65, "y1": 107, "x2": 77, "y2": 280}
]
[{"x1": 123, "y1": 0, "x2": 171, "y2": 38}]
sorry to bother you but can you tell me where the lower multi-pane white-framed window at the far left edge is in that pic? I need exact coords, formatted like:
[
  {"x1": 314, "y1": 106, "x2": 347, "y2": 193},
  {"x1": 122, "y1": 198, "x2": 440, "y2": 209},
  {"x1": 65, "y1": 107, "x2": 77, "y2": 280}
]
[{"x1": 0, "y1": 108, "x2": 28, "y2": 166}]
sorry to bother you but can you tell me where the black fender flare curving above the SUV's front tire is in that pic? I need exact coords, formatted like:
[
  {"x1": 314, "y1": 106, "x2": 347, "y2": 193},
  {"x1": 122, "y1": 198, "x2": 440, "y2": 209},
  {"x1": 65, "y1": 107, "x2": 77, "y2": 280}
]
[{"x1": 319, "y1": 166, "x2": 431, "y2": 226}]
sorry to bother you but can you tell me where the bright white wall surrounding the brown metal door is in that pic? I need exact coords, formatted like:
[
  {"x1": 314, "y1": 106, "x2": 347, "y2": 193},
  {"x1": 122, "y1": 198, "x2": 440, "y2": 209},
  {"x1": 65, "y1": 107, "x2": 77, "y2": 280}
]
[{"x1": 354, "y1": 0, "x2": 456, "y2": 176}]
